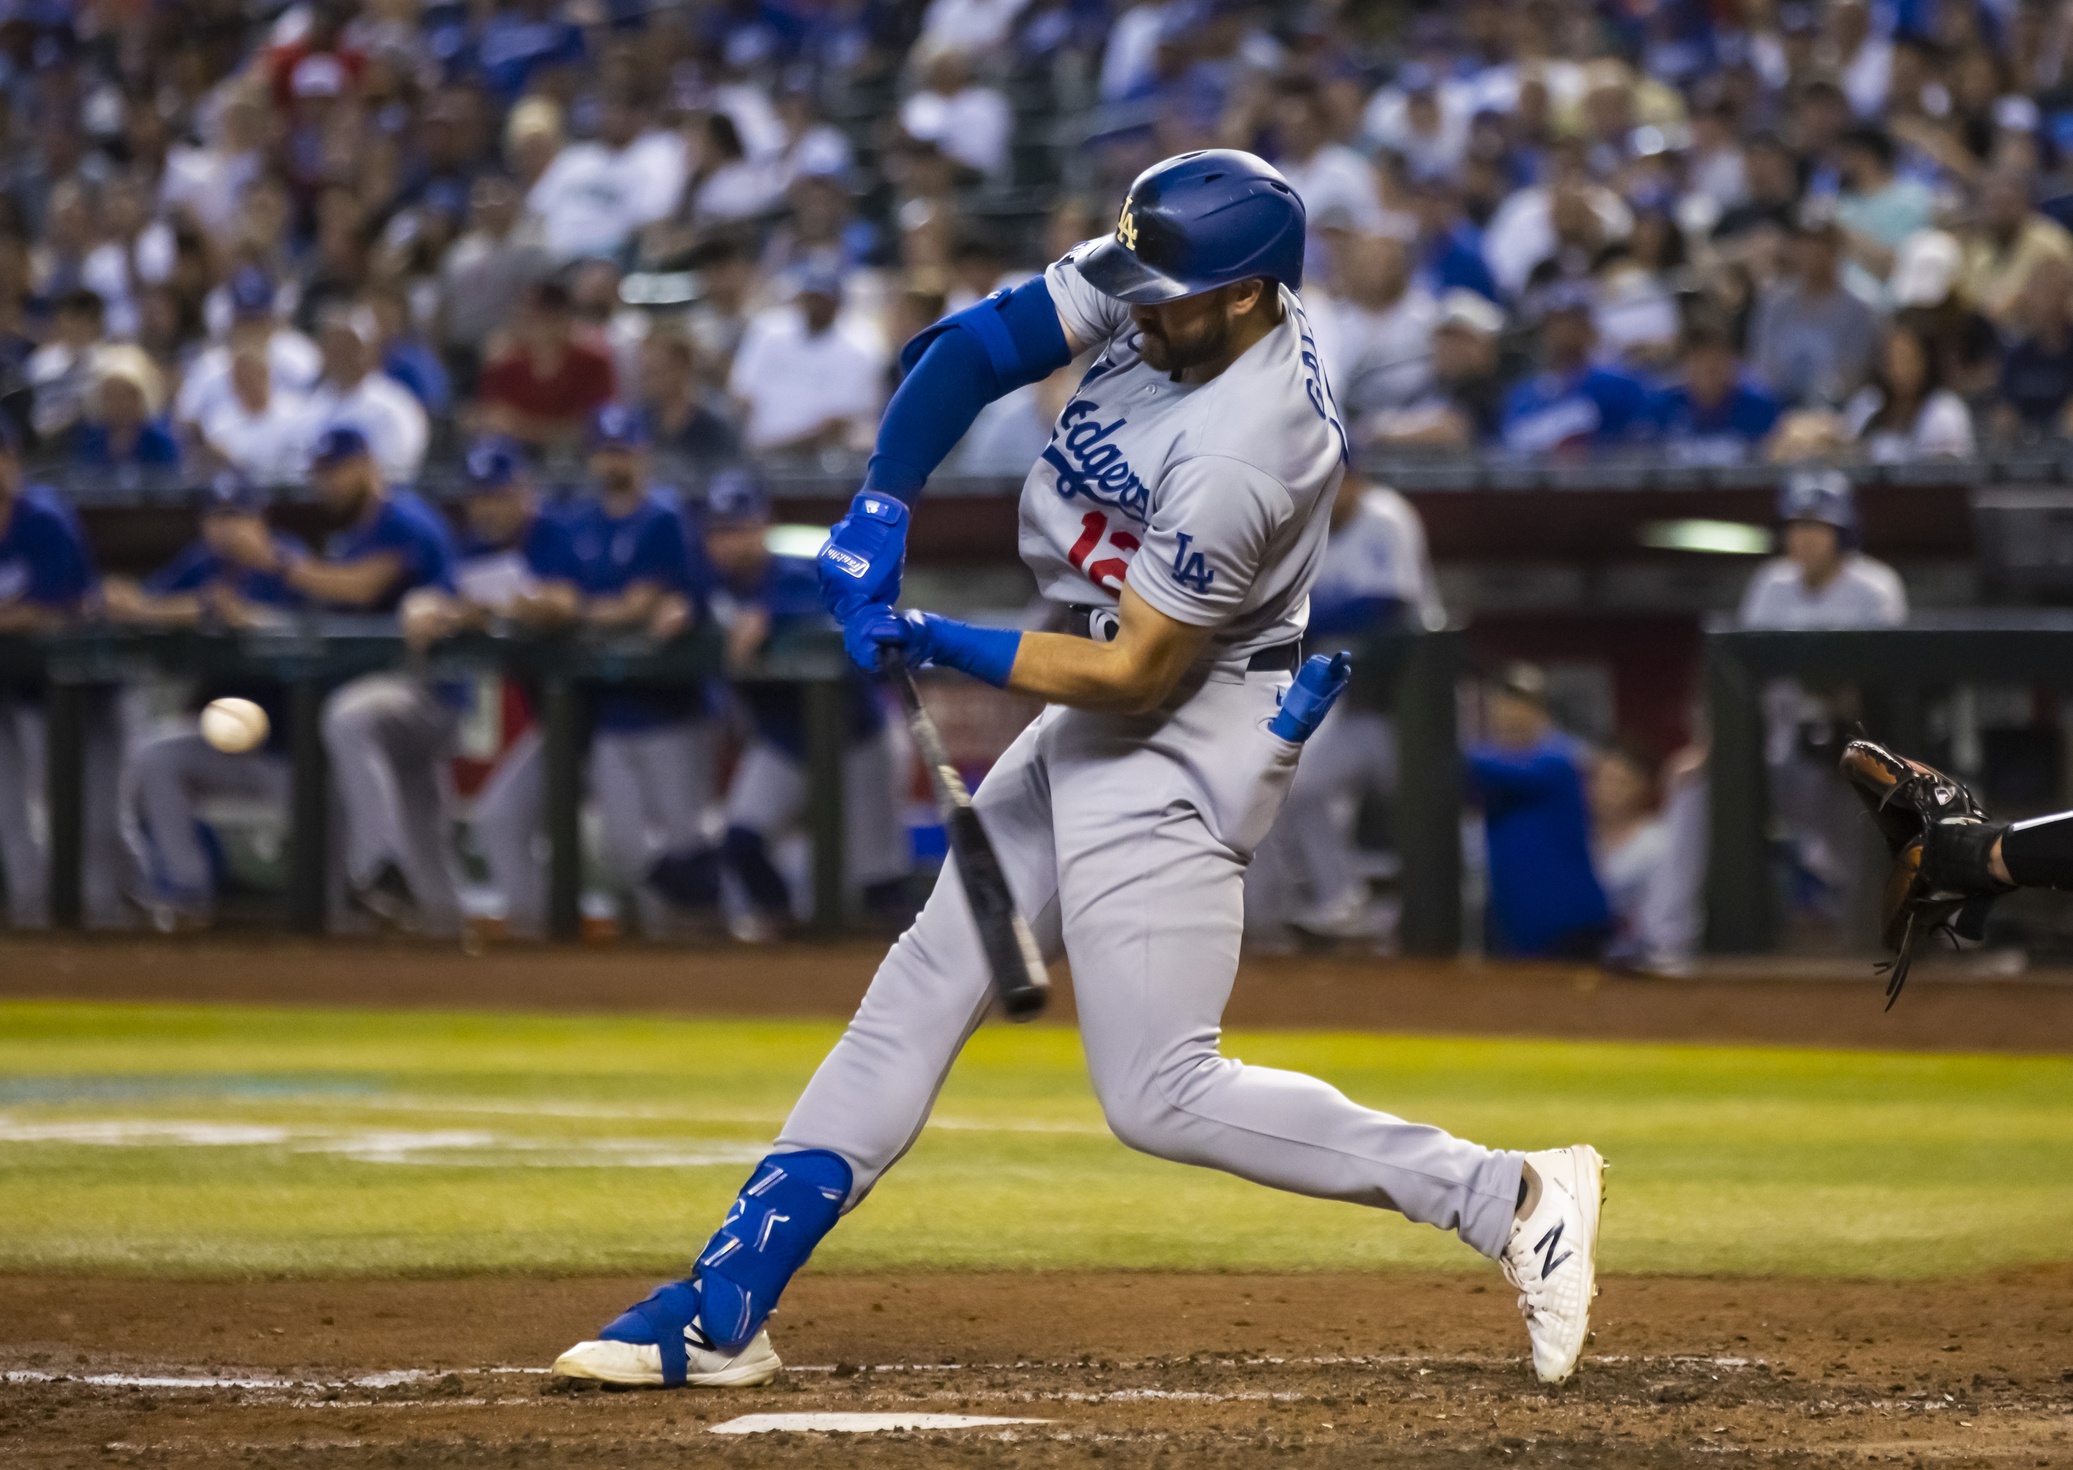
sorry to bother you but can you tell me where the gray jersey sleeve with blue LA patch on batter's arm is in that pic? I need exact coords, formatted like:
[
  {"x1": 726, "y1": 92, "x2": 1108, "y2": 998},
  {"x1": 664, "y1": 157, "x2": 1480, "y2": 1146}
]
[{"x1": 1130, "y1": 454, "x2": 1296, "y2": 628}]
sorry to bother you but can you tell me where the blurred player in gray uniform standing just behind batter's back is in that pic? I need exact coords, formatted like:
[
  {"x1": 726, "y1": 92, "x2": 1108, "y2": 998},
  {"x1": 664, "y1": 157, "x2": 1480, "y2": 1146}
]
[{"x1": 1246, "y1": 473, "x2": 1447, "y2": 945}]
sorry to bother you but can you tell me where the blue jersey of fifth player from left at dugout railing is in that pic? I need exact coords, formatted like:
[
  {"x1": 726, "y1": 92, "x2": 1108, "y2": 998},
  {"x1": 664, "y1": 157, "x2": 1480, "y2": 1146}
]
[{"x1": 566, "y1": 491, "x2": 707, "y2": 730}]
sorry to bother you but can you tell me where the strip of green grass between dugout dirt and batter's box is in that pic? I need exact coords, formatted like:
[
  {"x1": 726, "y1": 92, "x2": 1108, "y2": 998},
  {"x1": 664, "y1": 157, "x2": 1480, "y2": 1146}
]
[{"x1": 0, "y1": 1003, "x2": 2073, "y2": 1275}]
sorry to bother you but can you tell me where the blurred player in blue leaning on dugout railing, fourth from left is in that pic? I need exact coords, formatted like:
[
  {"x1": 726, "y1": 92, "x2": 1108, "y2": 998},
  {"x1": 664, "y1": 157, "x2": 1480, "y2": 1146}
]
[{"x1": 410, "y1": 437, "x2": 583, "y2": 939}]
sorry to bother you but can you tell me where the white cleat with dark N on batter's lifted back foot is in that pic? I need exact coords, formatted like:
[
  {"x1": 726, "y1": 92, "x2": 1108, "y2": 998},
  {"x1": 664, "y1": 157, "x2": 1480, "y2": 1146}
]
[{"x1": 1499, "y1": 1142, "x2": 1605, "y2": 1383}]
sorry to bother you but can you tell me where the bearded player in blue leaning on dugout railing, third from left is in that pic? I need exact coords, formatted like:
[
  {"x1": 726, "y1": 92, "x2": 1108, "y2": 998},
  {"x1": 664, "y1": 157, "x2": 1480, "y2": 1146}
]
[{"x1": 216, "y1": 425, "x2": 466, "y2": 935}]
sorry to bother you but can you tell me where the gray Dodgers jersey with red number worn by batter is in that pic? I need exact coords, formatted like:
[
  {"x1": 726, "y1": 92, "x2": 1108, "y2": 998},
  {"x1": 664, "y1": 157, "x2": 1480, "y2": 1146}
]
[{"x1": 1020, "y1": 245, "x2": 1345, "y2": 655}]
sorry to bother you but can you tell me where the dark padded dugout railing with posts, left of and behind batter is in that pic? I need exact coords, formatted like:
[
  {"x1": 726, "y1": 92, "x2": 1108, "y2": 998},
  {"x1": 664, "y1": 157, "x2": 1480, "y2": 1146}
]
[{"x1": 0, "y1": 616, "x2": 1464, "y2": 956}]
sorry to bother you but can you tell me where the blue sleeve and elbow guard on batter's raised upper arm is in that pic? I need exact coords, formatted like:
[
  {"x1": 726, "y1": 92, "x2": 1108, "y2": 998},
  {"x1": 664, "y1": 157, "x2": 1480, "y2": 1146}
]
[{"x1": 864, "y1": 276, "x2": 1072, "y2": 504}]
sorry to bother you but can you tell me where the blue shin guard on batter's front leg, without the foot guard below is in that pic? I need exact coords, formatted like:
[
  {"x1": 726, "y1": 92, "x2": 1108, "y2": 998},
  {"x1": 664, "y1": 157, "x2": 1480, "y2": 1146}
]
[{"x1": 699, "y1": 1149, "x2": 854, "y2": 1352}]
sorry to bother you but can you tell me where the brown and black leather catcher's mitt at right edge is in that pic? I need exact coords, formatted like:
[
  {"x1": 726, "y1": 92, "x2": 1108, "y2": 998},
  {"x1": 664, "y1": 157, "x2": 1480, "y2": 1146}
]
[{"x1": 1841, "y1": 740, "x2": 2007, "y2": 1010}]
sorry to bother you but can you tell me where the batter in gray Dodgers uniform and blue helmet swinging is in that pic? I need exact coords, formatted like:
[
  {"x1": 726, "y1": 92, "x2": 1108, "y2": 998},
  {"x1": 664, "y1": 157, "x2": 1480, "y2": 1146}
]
[{"x1": 556, "y1": 149, "x2": 1602, "y2": 1385}]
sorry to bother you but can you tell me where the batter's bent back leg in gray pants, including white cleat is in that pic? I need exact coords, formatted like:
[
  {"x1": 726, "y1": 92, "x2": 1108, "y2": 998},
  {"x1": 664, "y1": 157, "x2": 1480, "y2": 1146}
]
[{"x1": 1051, "y1": 676, "x2": 1602, "y2": 1381}]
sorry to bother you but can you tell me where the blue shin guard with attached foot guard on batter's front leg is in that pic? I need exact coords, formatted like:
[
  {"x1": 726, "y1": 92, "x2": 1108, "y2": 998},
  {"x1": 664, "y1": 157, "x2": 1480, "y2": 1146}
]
[{"x1": 597, "y1": 1149, "x2": 854, "y2": 1389}]
